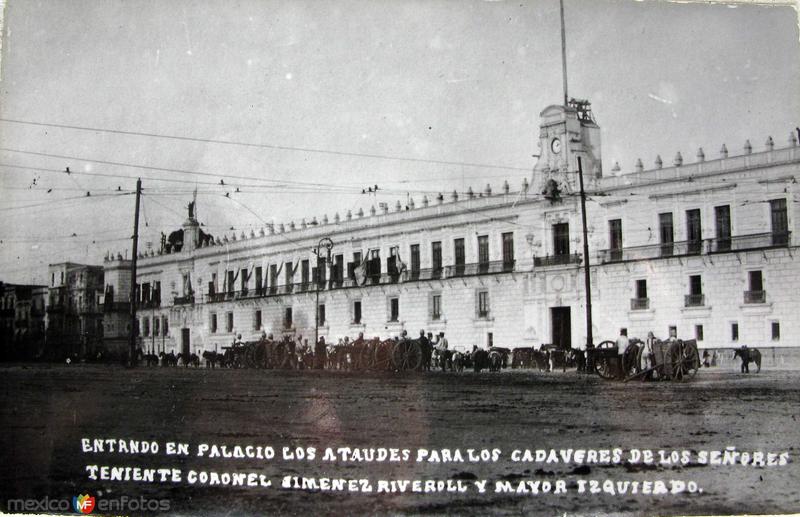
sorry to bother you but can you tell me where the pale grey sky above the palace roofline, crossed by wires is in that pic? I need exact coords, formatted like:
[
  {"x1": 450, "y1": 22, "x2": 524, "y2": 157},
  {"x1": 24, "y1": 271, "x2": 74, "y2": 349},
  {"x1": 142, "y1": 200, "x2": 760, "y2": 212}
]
[{"x1": 0, "y1": 0, "x2": 800, "y2": 283}]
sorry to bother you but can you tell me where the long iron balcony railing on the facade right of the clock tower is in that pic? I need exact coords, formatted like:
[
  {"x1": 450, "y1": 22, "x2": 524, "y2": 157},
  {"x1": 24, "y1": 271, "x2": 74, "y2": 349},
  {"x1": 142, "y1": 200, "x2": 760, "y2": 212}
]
[{"x1": 598, "y1": 231, "x2": 791, "y2": 264}]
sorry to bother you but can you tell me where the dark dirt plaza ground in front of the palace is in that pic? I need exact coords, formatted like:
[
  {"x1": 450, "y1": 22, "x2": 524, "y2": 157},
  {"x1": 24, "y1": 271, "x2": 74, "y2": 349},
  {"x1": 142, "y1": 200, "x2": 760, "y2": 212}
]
[{"x1": 0, "y1": 364, "x2": 800, "y2": 515}]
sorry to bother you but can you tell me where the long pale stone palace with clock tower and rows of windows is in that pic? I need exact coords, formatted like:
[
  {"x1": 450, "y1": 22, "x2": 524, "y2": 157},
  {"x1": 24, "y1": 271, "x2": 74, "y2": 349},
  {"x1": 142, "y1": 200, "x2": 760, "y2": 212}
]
[{"x1": 104, "y1": 101, "x2": 800, "y2": 358}]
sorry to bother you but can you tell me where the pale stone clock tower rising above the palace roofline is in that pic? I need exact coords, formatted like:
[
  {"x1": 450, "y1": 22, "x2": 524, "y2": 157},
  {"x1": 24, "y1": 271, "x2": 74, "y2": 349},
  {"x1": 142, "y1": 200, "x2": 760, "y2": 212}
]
[{"x1": 531, "y1": 99, "x2": 603, "y2": 197}]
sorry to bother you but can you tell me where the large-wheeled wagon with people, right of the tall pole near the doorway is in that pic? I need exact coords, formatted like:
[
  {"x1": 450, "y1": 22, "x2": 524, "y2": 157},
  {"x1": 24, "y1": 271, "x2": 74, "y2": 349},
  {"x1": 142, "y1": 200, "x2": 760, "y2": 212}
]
[{"x1": 591, "y1": 338, "x2": 700, "y2": 382}]
